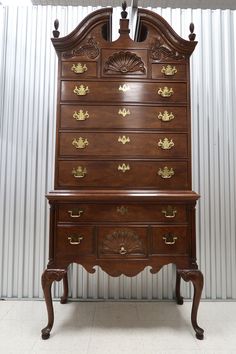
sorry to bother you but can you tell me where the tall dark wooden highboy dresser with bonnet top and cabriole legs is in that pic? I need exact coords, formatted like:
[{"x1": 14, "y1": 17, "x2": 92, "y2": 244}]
[{"x1": 42, "y1": 3, "x2": 203, "y2": 339}]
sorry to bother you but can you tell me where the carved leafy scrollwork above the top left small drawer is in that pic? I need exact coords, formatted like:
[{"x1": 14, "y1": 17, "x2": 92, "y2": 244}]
[{"x1": 63, "y1": 37, "x2": 100, "y2": 59}]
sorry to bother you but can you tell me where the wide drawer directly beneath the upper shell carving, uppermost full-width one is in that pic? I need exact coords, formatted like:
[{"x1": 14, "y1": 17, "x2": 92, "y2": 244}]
[{"x1": 61, "y1": 80, "x2": 187, "y2": 103}]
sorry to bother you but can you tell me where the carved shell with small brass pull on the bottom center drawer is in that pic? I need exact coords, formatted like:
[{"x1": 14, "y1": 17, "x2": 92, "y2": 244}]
[{"x1": 102, "y1": 230, "x2": 145, "y2": 255}]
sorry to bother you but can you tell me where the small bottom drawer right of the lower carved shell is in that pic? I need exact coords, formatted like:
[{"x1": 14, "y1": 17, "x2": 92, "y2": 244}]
[{"x1": 151, "y1": 225, "x2": 190, "y2": 255}]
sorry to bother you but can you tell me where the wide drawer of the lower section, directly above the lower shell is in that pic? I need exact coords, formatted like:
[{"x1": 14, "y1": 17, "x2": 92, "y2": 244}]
[{"x1": 58, "y1": 203, "x2": 187, "y2": 223}]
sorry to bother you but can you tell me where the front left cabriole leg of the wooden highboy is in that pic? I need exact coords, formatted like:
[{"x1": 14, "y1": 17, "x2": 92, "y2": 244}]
[{"x1": 41, "y1": 269, "x2": 66, "y2": 339}]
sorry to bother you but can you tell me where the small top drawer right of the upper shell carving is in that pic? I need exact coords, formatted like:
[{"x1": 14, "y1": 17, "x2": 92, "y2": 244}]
[{"x1": 152, "y1": 63, "x2": 187, "y2": 81}]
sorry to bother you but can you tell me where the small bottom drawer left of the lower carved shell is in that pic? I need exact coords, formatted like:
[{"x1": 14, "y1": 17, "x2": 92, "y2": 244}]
[{"x1": 55, "y1": 225, "x2": 95, "y2": 257}]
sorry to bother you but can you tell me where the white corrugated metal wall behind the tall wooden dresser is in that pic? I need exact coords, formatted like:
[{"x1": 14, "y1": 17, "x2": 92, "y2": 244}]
[{"x1": 0, "y1": 6, "x2": 236, "y2": 299}]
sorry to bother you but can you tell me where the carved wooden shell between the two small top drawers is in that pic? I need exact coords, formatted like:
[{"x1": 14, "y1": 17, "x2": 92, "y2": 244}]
[{"x1": 104, "y1": 51, "x2": 146, "y2": 74}]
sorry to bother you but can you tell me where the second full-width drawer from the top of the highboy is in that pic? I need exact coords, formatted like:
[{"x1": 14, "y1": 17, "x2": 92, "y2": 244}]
[{"x1": 60, "y1": 104, "x2": 187, "y2": 130}]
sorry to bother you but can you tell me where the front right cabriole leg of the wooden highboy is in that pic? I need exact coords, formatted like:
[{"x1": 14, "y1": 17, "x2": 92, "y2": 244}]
[{"x1": 177, "y1": 269, "x2": 204, "y2": 339}]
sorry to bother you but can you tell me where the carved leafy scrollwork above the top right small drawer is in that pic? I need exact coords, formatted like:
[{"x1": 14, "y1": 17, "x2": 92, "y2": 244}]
[{"x1": 150, "y1": 37, "x2": 185, "y2": 61}]
